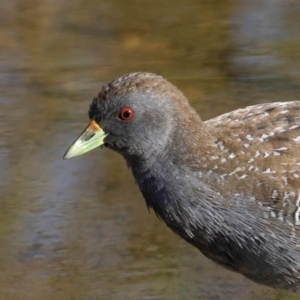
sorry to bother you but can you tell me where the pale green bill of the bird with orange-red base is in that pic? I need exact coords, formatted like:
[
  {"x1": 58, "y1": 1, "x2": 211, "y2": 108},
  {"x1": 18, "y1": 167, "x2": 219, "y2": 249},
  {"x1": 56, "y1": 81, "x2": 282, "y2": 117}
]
[{"x1": 64, "y1": 120, "x2": 107, "y2": 159}]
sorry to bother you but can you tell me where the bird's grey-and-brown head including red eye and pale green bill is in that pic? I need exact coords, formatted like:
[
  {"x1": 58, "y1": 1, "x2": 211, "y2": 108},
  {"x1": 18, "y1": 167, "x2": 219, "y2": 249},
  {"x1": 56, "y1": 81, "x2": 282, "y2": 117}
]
[{"x1": 64, "y1": 72, "x2": 197, "y2": 159}]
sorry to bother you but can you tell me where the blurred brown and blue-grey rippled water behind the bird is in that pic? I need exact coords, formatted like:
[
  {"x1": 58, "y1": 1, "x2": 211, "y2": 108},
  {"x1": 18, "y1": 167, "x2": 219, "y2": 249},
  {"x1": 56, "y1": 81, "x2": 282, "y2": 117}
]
[{"x1": 0, "y1": 0, "x2": 300, "y2": 300}]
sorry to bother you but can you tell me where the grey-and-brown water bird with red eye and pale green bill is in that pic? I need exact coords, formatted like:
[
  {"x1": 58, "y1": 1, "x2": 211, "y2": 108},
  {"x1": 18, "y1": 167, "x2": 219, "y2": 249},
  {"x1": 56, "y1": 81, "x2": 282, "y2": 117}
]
[{"x1": 64, "y1": 72, "x2": 300, "y2": 292}]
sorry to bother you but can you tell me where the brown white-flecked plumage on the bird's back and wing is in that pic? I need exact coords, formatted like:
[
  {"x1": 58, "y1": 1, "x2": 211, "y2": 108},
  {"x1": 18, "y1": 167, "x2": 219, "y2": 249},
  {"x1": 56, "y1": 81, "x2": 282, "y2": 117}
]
[{"x1": 206, "y1": 101, "x2": 300, "y2": 223}]
